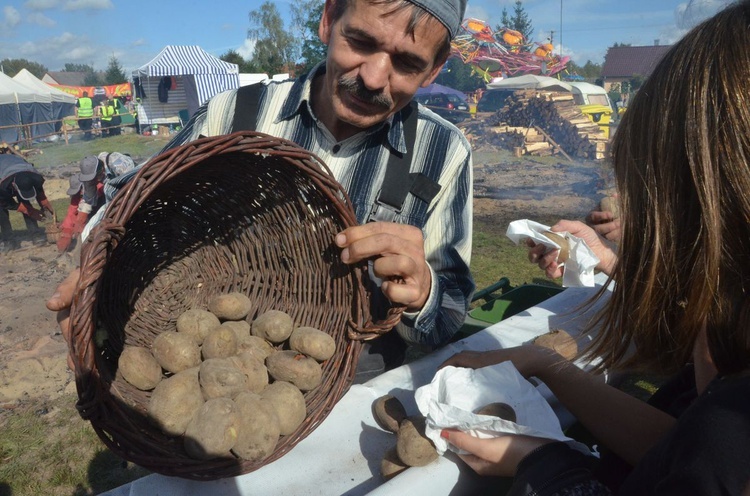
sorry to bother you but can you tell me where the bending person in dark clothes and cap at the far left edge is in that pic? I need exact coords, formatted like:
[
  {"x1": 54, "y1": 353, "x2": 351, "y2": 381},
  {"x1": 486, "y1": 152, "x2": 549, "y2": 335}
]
[{"x1": 0, "y1": 144, "x2": 53, "y2": 249}]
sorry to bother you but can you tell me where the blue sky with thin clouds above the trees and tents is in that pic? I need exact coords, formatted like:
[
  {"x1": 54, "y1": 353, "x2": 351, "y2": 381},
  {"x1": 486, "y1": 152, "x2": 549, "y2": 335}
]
[{"x1": 0, "y1": 0, "x2": 727, "y2": 74}]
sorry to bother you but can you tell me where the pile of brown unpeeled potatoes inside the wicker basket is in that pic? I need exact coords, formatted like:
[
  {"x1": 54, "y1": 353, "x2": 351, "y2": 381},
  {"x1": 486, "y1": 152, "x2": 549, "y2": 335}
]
[{"x1": 118, "y1": 293, "x2": 336, "y2": 462}]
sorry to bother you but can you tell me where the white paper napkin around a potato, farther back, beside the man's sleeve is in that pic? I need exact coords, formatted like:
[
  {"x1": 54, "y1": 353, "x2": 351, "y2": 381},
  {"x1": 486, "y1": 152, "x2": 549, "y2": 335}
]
[{"x1": 505, "y1": 219, "x2": 599, "y2": 288}]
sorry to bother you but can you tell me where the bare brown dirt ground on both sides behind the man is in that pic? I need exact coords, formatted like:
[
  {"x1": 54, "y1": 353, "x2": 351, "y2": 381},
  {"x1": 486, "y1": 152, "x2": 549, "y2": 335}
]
[{"x1": 0, "y1": 142, "x2": 609, "y2": 410}]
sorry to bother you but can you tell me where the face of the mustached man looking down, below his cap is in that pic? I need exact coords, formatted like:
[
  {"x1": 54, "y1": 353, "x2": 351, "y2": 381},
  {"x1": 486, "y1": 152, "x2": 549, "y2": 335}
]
[{"x1": 316, "y1": 0, "x2": 447, "y2": 135}]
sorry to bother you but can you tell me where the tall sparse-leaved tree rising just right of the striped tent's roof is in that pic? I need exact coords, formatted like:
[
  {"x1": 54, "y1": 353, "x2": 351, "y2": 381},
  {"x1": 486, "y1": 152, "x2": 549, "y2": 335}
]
[{"x1": 247, "y1": 0, "x2": 299, "y2": 74}]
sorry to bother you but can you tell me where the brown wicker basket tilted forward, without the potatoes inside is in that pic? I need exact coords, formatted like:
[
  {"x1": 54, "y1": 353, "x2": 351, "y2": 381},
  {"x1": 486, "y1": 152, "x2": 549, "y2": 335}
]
[{"x1": 70, "y1": 132, "x2": 403, "y2": 480}]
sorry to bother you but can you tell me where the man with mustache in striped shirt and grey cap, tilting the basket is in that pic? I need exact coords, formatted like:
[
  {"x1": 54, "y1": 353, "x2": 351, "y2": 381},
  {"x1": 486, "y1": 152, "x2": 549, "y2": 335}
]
[{"x1": 48, "y1": 0, "x2": 474, "y2": 382}]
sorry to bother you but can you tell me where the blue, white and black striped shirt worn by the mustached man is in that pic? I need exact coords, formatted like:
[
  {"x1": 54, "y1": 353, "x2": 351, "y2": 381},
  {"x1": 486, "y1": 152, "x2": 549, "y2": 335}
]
[{"x1": 88, "y1": 64, "x2": 474, "y2": 347}]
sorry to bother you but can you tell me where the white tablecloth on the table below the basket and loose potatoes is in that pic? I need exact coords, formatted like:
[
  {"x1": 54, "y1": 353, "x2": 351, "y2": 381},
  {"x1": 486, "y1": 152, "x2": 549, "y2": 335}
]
[{"x1": 105, "y1": 277, "x2": 602, "y2": 496}]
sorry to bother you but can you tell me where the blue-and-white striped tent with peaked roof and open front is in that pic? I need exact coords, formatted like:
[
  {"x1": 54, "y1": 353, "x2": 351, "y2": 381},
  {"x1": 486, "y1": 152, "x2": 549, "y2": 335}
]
[{"x1": 133, "y1": 45, "x2": 240, "y2": 129}]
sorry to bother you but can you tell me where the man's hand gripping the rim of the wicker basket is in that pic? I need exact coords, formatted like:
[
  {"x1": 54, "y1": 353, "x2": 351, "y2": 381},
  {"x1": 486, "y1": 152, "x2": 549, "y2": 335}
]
[{"x1": 336, "y1": 222, "x2": 432, "y2": 312}]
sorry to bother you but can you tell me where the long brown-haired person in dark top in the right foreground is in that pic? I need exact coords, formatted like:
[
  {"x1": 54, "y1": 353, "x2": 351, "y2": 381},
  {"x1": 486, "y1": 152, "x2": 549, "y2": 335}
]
[{"x1": 442, "y1": 0, "x2": 750, "y2": 496}]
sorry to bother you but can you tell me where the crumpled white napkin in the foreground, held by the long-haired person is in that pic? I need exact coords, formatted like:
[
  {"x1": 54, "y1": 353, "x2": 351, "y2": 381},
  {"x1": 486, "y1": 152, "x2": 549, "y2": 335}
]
[{"x1": 414, "y1": 362, "x2": 591, "y2": 455}]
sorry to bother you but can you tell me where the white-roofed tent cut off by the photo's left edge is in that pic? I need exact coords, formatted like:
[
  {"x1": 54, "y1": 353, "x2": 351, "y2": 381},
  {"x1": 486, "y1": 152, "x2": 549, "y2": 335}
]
[{"x1": 0, "y1": 72, "x2": 54, "y2": 143}]
